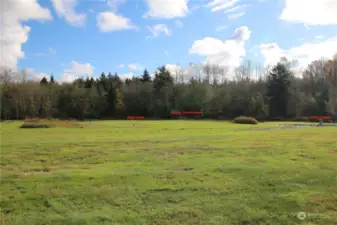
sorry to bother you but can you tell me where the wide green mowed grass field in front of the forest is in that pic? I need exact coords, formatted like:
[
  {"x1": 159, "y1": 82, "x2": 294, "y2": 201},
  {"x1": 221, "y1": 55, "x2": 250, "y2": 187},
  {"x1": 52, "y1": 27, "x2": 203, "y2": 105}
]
[{"x1": 0, "y1": 121, "x2": 337, "y2": 225}]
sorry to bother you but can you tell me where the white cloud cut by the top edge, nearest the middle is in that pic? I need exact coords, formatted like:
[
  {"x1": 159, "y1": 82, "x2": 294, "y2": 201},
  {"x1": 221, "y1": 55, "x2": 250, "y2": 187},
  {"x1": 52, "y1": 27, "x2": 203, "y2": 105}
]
[{"x1": 144, "y1": 0, "x2": 189, "y2": 19}]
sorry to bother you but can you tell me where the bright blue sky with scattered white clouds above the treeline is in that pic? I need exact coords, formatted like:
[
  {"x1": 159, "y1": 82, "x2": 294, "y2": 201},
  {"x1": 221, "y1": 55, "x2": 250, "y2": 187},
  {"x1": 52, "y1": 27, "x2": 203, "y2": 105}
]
[{"x1": 0, "y1": 0, "x2": 337, "y2": 81}]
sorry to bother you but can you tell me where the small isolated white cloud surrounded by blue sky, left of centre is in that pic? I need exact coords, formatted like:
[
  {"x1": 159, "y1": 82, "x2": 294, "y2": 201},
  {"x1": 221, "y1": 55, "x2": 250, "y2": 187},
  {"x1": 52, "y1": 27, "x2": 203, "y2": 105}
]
[{"x1": 97, "y1": 12, "x2": 137, "y2": 32}]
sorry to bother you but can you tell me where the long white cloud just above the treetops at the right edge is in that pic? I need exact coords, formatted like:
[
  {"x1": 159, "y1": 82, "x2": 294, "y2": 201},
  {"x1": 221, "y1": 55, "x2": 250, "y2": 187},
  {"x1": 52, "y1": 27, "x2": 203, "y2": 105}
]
[{"x1": 260, "y1": 36, "x2": 337, "y2": 71}]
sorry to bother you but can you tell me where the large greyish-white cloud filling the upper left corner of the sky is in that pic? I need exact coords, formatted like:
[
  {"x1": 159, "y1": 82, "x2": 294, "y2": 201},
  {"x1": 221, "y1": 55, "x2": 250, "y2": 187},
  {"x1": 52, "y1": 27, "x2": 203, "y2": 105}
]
[{"x1": 0, "y1": 0, "x2": 52, "y2": 71}]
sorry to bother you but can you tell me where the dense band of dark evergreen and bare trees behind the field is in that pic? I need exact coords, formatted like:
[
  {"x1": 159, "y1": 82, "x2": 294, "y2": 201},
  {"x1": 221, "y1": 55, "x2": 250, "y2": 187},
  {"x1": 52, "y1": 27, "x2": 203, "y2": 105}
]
[{"x1": 0, "y1": 55, "x2": 337, "y2": 120}]
